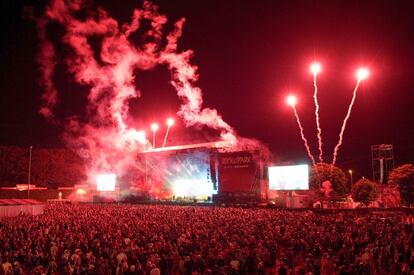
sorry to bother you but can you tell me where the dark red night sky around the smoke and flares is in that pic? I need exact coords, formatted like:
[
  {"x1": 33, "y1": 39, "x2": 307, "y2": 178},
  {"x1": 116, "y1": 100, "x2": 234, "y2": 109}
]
[{"x1": 0, "y1": 0, "x2": 414, "y2": 179}]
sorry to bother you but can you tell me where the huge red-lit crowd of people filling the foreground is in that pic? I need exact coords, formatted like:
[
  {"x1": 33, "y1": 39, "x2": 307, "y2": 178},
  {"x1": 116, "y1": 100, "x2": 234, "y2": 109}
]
[{"x1": 0, "y1": 204, "x2": 414, "y2": 275}]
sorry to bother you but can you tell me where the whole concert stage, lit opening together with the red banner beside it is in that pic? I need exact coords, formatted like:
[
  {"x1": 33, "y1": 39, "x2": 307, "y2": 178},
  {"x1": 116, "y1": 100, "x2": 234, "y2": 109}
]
[{"x1": 139, "y1": 143, "x2": 263, "y2": 201}]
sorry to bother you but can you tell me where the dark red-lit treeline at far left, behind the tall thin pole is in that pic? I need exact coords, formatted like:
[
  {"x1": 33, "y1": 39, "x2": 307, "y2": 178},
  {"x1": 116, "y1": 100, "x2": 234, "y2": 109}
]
[{"x1": 0, "y1": 146, "x2": 86, "y2": 188}]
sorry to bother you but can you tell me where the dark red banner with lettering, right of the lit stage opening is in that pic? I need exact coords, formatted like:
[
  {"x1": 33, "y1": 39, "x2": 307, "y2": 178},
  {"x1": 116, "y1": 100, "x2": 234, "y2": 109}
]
[{"x1": 219, "y1": 151, "x2": 260, "y2": 193}]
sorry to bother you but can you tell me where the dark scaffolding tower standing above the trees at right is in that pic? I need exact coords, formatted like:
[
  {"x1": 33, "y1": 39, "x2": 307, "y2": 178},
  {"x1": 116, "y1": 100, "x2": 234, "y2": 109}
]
[{"x1": 371, "y1": 144, "x2": 395, "y2": 183}]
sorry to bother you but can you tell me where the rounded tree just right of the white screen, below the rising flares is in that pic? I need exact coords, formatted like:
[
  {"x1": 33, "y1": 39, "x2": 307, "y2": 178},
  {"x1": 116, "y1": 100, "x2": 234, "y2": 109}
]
[{"x1": 309, "y1": 163, "x2": 351, "y2": 198}]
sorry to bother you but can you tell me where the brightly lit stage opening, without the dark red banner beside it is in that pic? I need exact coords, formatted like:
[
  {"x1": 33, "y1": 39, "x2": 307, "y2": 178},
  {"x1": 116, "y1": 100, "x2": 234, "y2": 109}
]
[{"x1": 140, "y1": 147, "x2": 217, "y2": 200}]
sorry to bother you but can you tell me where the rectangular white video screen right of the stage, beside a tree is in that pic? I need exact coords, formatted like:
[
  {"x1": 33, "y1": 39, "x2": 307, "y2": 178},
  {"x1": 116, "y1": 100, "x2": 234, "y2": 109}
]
[{"x1": 268, "y1": 164, "x2": 309, "y2": 190}]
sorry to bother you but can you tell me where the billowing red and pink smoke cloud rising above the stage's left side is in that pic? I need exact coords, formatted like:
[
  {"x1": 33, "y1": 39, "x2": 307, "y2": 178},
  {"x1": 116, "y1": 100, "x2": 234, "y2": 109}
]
[{"x1": 38, "y1": 0, "x2": 236, "y2": 185}]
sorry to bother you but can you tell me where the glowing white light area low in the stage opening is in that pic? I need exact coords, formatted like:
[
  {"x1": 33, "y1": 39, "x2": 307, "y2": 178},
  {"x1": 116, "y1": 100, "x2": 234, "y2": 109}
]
[{"x1": 172, "y1": 179, "x2": 213, "y2": 197}]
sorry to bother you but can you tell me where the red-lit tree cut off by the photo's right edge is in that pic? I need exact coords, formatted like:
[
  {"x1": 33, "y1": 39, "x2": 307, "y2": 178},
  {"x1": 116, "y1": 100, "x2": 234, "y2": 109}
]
[{"x1": 388, "y1": 164, "x2": 414, "y2": 205}]
